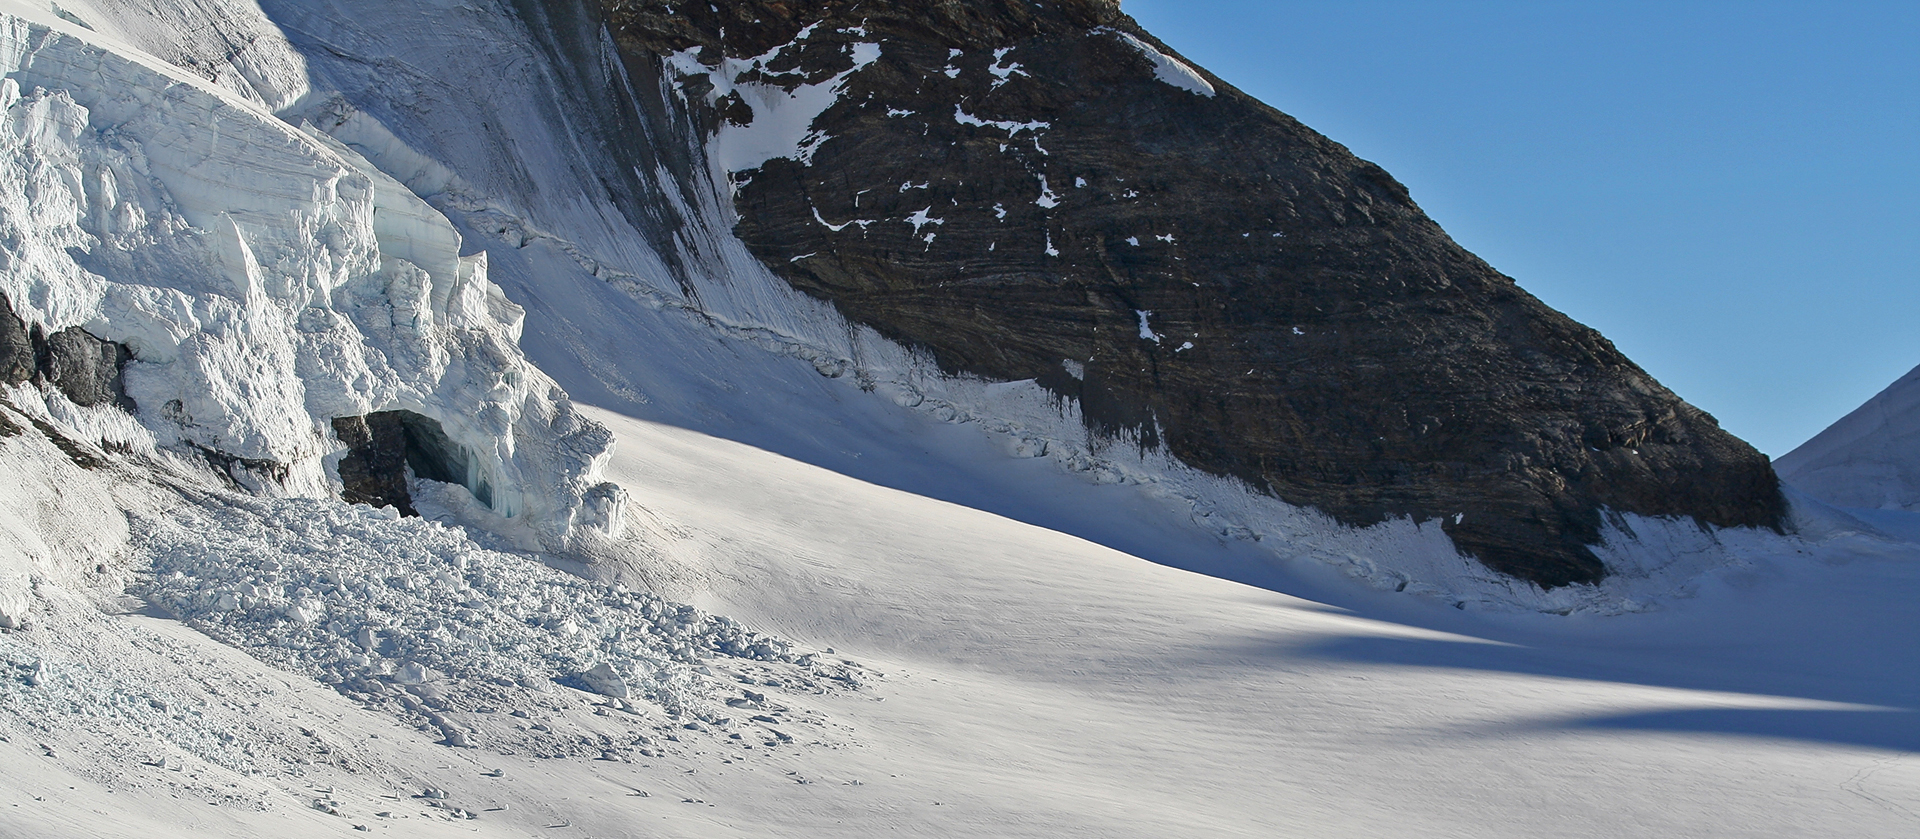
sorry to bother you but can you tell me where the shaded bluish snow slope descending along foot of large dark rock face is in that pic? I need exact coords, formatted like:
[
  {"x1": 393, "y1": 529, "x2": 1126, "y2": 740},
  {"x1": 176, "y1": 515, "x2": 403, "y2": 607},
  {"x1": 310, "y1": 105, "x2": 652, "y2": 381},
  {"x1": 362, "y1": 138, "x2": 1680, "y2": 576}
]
[{"x1": 26, "y1": 0, "x2": 1797, "y2": 611}]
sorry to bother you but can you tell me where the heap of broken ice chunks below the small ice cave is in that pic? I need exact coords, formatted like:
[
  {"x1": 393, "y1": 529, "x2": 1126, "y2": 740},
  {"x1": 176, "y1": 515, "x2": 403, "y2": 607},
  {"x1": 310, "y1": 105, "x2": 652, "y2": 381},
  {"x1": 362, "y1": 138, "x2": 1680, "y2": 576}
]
[{"x1": 134, "y1": 495, "x2": 864, "y2": 756}]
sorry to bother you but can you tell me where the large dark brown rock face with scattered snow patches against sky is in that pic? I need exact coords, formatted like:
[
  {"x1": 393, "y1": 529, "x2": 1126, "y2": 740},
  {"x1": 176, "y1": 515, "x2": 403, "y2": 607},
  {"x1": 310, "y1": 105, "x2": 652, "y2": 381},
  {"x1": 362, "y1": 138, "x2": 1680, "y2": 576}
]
[{"x1": 603, "y1": 0, "x2": 1784, "y2": 586}]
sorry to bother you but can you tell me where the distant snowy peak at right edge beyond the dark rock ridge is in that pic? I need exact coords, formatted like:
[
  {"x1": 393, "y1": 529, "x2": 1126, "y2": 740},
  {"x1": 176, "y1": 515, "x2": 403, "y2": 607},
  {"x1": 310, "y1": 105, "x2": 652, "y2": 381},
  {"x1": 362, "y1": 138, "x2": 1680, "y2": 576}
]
[{"x1": 1774, "y1": 367, "x2": 1920, "y2": 513}]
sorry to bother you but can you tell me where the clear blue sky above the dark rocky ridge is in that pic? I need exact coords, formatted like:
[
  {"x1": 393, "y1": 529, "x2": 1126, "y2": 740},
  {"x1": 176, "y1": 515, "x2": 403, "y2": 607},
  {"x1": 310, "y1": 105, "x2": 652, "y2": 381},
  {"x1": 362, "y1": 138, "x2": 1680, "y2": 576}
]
[{"x1": 1121, "y1": 0, "x2": 1920, "y2": 457}]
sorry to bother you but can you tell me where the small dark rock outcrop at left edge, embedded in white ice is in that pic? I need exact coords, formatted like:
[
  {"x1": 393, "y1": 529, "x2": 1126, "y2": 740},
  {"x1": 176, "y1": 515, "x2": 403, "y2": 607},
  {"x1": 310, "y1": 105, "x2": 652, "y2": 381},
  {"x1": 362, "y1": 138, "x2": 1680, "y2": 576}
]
[{"x1": 0, "y1": 294, "x2": 134, "y2": 413}]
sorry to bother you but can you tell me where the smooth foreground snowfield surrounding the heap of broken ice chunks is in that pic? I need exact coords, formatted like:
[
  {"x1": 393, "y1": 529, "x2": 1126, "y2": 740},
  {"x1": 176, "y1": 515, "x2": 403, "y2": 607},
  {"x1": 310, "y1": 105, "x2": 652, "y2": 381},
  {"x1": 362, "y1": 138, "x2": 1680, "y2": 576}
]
[{"x1": 0, "y1": 401, "x2": 1920, "y2": 837}]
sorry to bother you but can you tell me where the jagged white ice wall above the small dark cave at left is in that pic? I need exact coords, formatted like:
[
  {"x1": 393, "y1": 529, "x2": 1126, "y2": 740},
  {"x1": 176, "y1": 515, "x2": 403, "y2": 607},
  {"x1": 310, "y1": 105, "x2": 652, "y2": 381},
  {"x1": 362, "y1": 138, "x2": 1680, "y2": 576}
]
[{"x1": 0, "y1": 0, "x2": 618, "y2": 549}]
